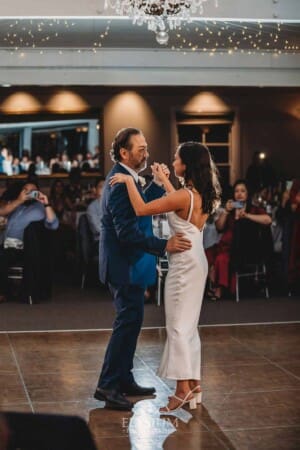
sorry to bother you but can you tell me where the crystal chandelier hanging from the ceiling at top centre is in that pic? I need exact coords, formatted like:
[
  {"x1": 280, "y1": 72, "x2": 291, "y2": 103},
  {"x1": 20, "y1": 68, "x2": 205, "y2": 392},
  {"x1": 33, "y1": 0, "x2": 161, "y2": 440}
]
[{"x1": 104, "y1": 0, "x2": 217, "y2": 45}]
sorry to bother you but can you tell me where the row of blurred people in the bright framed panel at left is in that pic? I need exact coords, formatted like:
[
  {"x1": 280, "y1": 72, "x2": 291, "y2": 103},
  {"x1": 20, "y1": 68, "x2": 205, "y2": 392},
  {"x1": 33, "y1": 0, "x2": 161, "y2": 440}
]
[{"x1": 0, "y1": 147, "x2": 100, "y2": 176}]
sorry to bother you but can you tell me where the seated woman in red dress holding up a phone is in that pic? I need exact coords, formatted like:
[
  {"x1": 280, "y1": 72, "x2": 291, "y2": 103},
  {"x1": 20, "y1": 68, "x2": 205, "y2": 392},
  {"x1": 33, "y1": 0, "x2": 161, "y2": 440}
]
[{"x1": 209, "y1": 180, "x2": 271, "y2": 299}]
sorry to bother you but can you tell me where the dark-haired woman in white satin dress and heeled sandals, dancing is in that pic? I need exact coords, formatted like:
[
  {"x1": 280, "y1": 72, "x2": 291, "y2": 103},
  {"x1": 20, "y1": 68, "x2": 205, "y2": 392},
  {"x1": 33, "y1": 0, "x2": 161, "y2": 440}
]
[{"x1": 110, "y1": 142, "x2": 221, "y2": 413}]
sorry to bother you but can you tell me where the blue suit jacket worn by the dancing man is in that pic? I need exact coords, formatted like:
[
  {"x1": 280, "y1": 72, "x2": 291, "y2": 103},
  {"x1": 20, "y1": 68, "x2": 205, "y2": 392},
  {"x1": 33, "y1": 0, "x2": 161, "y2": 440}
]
[{"x1": 99, "y1": 164, "x2": 167, "y2": 287}]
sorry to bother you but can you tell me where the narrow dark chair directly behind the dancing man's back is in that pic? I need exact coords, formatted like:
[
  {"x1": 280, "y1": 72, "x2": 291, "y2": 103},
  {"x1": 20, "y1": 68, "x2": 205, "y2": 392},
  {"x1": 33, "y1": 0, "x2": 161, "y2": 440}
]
[{"x1": 77, "y1": 214, "x2": 98, "y2": 289}]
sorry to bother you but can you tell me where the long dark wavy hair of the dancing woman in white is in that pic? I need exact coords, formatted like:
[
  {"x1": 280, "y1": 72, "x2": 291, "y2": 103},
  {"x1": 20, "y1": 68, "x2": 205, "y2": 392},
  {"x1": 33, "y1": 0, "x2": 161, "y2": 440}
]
[{"x1": 178, "y1": 142, "x2": 221, "y2": 214}]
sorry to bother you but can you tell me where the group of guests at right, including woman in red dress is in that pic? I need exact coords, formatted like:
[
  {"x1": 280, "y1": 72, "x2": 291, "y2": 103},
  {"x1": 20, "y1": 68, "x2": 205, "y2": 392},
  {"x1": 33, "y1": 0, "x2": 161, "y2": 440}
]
[{"x1": 204, "y1": 180, "x2": 300, "y2": 300}]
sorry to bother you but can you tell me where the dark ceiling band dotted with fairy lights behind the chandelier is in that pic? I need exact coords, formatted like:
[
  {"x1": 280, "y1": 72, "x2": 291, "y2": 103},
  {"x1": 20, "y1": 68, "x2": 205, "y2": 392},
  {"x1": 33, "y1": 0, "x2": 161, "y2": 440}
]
[{"x1": 0, "y1": 17, "x2": 300, "y2": 54}]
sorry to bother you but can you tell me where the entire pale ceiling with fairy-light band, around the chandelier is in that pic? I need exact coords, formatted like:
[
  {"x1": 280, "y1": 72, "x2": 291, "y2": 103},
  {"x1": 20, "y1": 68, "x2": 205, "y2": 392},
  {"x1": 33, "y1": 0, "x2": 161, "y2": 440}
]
[{"x1": 0, "y1": 0, "x2": 300, "y2": 87}]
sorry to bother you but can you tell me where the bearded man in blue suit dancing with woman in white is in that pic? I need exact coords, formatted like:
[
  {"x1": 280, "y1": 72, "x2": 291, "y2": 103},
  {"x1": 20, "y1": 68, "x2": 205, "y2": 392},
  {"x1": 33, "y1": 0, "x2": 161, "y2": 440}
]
[{"x1": 94, "y1": 128, "x2": 191, "y2": 410}]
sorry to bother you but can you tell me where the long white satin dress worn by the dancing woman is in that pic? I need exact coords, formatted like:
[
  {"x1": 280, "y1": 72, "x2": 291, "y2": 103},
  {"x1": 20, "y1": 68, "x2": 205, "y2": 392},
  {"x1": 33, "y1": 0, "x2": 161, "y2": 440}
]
[{"x1": 158, "y1": 189, "x2": 208, "y2": 380}]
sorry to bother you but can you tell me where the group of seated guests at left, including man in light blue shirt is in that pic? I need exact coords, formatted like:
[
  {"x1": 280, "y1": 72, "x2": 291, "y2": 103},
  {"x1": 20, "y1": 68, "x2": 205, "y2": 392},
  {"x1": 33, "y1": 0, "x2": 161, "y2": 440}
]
[{"x1": 0, "y1": 174, "x2": 104, "y2": 301}]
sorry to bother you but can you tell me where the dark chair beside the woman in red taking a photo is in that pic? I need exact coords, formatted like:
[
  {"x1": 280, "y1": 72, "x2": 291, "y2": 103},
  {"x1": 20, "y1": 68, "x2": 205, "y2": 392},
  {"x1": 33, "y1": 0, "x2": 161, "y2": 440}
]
[{"x1": 231, "y1": 220, "x2": 273, "y2": 302}]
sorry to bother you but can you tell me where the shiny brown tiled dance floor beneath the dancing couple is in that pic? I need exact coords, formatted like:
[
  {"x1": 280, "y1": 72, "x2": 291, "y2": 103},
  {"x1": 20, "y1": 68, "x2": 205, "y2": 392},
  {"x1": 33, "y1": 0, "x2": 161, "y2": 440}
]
[{"x1": 0, "y1": 324, "x2": 300, "y2": 450}]
